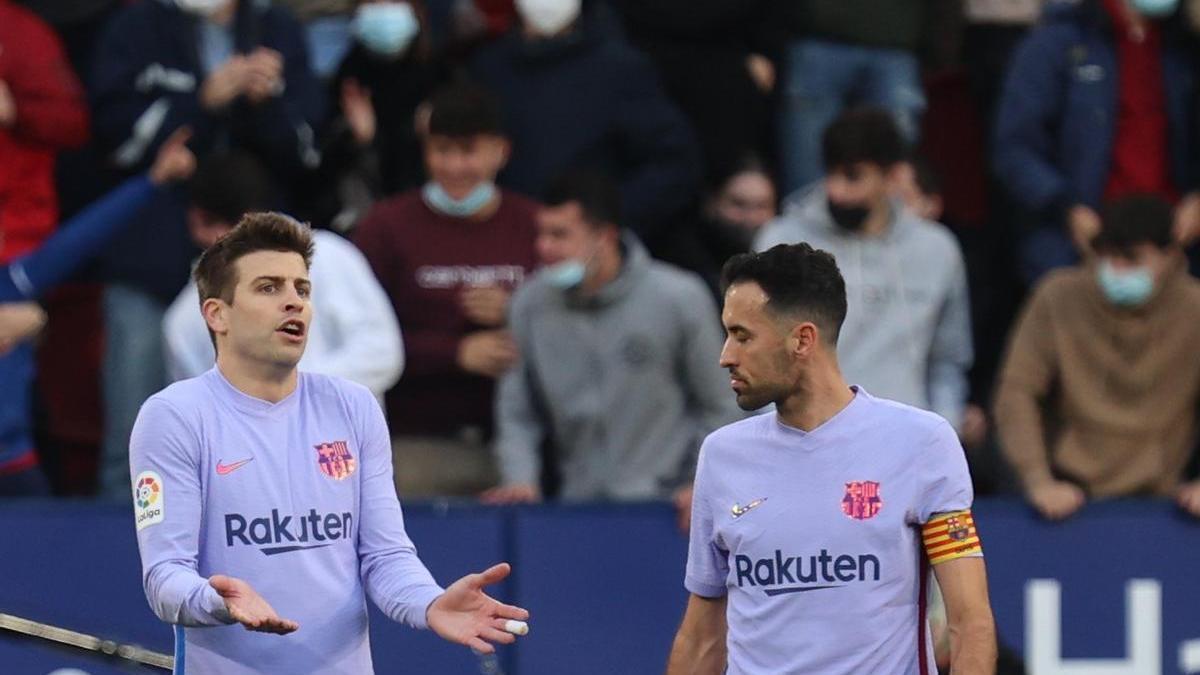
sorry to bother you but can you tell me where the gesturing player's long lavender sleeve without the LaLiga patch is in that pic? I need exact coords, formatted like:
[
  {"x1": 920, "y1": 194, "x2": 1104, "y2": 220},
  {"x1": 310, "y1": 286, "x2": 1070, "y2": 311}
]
[{"x1": 354, "y1": 388, "x2": 445, "y2": 628}]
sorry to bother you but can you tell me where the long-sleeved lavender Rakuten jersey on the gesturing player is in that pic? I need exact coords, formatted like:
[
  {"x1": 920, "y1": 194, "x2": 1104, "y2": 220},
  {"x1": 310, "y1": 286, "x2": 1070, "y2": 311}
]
[{"x1": 130, "y1": 369, "x2": 442, "y2": 675}]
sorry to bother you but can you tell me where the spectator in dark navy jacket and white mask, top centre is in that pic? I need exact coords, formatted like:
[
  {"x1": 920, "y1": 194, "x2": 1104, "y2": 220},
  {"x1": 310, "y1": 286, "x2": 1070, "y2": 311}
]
[{"x1": 470, "y1": 0, "x2": 700, "y2": 239}]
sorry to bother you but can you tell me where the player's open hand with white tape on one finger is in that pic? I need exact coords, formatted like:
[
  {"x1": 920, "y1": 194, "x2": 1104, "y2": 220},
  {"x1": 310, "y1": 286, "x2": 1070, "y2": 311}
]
[{"x1": 425, "y1": 562, "x2": 529, "y2": 653}]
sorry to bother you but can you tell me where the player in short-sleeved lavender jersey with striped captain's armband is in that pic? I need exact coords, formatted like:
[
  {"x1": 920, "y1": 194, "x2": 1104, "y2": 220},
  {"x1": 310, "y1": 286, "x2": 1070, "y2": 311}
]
[{"x1": 667, "y1": 244, "x2": 996, "y2": 675}]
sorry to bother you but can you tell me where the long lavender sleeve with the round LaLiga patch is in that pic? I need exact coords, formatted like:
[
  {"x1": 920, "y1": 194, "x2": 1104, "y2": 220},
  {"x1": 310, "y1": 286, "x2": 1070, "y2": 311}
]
[{"x1": 130, "y1": 398, "x2": 234, "y2": 626}]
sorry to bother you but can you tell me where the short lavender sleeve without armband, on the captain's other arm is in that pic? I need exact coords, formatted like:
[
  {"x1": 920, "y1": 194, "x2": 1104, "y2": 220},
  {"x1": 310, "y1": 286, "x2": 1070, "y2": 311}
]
[{"x1": 683, "y1": 441, "x2": 730, "y2": 598}]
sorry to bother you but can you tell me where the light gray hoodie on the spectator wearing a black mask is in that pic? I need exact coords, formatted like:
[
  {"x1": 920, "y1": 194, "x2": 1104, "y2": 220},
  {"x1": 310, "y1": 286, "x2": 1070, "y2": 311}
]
[{"x1": 754, "y1": 183, "x2": 973, "y2": 428}]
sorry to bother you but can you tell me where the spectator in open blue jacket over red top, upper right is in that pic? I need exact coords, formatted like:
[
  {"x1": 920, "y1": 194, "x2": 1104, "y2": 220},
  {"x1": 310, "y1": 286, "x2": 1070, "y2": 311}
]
[{"x1": 994, "y1": 0, "x2": 1200, "y2": 283}]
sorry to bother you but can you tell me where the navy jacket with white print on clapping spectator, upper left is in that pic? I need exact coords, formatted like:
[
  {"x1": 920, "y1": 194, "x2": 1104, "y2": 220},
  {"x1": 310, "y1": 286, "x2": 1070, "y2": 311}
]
[{"x1": 89, "y1": 0, "x2": 323, "y2": 303}]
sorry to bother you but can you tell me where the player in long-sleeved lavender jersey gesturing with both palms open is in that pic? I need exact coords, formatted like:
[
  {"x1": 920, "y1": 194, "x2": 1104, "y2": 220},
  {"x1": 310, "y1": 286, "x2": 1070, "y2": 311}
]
[{"x1": 130, "y1": 213, "x2": 528, "y2": 675}]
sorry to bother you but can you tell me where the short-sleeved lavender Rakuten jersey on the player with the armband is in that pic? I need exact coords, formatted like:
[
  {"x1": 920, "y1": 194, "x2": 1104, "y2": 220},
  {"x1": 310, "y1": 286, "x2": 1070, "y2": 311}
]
[{"x1": 684, "y1": 389, "x2": 972, "y2": 675}]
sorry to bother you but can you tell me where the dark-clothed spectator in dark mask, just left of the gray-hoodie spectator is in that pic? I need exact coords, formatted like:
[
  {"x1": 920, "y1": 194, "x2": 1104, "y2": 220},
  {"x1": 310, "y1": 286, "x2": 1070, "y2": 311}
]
[{"x1": 661, "y1": 155, "x2": 779, "y2": 303}]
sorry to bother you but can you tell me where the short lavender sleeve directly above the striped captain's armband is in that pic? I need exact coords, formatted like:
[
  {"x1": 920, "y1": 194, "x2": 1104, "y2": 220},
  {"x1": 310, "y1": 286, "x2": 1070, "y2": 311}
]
[{"x1": 914, "y1": 420, "x2": 974, "y2": 525}]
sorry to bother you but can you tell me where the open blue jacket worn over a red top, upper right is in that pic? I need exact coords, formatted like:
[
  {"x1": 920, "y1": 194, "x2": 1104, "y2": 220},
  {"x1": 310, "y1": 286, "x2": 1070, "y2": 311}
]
[{"x1": 992, "y1": 0, "x2": 1196, "y2": 214}]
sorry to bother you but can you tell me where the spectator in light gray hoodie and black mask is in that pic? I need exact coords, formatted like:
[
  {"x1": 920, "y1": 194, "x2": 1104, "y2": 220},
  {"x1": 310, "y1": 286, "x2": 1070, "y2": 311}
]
[{"x1": 754, "y1": 108, "x2": 972, "y2": 432}]
